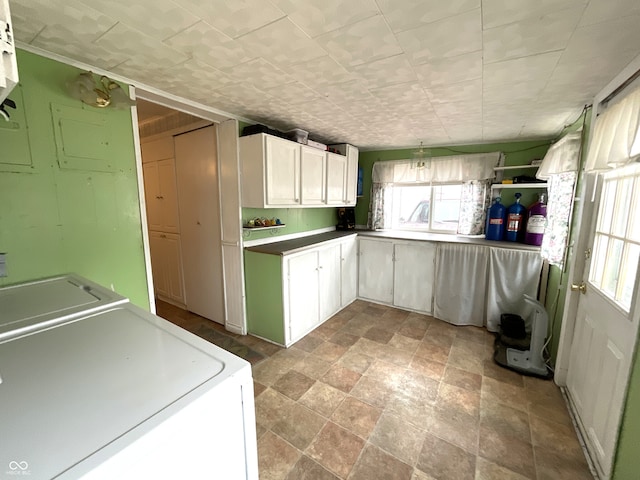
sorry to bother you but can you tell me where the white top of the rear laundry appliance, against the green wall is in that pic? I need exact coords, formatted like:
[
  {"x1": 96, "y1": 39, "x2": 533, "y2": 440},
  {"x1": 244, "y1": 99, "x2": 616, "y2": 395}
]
[{"x1": 0, "y1": 275, "x2": 128, "y2": 341}]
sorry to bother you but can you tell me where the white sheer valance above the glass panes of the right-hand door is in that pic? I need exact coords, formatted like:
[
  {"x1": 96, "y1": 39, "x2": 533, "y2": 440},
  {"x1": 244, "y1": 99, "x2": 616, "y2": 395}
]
[{"x1": 585, "y1": 86, "x2": 640, "y2": 172}]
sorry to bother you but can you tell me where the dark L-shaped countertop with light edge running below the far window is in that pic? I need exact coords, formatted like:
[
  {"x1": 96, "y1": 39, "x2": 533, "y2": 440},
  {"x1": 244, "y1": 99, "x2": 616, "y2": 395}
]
[{"x1": 245, "y1": 230, "x2": 540, "y2": 255}]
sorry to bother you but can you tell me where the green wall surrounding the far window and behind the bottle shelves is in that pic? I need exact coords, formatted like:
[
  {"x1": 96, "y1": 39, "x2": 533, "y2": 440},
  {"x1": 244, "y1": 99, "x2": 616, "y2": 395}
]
[{"x1": 356, "y1": 140, "x2": 551, "y2": 225}]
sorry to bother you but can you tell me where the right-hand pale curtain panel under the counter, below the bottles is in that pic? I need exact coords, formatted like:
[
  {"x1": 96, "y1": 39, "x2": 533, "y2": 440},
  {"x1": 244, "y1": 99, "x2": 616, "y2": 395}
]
[{"x1": 487, "y1": 248, "x2": 542, "y2": 332}]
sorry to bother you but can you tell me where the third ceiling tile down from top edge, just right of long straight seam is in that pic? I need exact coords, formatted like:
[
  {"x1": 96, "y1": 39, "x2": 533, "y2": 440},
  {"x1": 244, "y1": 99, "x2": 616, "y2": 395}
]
[{"x1": 482, "y1": 51, "x2": 562, "y2": 87}]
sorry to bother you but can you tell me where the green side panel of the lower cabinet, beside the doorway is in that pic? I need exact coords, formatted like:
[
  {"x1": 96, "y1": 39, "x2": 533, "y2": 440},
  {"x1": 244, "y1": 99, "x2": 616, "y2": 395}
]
[{"x1": 244, "y1": 250, "x2": 284, "y2": 345}]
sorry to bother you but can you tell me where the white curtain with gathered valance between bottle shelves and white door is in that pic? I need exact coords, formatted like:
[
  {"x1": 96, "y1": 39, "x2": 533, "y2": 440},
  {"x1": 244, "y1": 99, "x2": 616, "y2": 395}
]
[{"x1": 536, "y1": 132, "x2": 582, "y2": 268}]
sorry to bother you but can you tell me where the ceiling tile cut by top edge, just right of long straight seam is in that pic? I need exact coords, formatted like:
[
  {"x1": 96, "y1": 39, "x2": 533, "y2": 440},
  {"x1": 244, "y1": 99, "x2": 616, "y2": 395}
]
[{"x1": 482, "y1": 0, "x2": 588, "y2": 29}]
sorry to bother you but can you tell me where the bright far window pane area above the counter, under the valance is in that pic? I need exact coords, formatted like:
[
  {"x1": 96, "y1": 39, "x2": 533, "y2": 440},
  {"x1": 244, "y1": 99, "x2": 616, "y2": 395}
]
[{"x1": 387, "y1": 184, "x2": 462, "y2": 233}]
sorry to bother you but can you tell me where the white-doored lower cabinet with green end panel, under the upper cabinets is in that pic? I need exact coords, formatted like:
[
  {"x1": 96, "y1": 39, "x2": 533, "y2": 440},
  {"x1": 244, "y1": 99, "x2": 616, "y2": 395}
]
[{"x1": 245, "y1": 236, "x2": 357, "y2": 347}]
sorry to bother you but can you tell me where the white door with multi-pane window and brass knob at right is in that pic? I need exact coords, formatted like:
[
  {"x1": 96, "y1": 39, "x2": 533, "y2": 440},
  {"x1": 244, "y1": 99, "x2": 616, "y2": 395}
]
[{"x1": 567, "y1": 165, "x2": 640, "y2": 478}]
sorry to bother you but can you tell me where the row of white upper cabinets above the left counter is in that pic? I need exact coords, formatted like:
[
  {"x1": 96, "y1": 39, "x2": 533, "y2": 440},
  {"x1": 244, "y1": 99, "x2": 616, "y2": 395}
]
[{"x1": 240, "y1": 133, "x2": 358, "y2": 208}]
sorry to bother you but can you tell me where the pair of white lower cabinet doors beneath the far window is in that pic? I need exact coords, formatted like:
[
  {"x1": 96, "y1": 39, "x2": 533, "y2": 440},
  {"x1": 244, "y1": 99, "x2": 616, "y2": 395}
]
[{"x1": 358, "y1": 238, "x2": 436, "y2": 314}]
